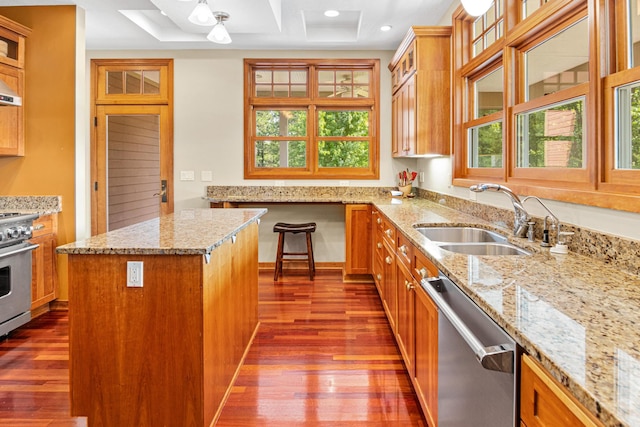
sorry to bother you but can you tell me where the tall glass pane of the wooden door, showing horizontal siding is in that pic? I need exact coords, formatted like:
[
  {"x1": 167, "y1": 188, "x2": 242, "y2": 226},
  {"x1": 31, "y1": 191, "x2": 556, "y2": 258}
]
[{"x1": 106, "y1": 115, "x2": 160, "y2": 230}]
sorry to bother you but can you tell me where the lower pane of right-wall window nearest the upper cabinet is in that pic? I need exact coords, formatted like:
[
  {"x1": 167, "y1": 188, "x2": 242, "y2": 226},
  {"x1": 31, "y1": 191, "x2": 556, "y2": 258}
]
[{"x1": 468, "y1": 120, "x2": 502, "y2": 168}]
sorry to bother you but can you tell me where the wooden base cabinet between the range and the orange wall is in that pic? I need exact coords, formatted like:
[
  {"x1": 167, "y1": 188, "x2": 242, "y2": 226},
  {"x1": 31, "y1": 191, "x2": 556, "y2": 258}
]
[{"x1": 30, "y1": 214, "x2": 58, "y2": 311}]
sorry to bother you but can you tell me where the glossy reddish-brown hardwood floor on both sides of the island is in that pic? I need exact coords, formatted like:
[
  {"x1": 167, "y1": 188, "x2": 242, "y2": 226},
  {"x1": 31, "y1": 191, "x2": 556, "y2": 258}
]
[{"x1": 0, "y1": 270, "x2": 426, "y2": 427}]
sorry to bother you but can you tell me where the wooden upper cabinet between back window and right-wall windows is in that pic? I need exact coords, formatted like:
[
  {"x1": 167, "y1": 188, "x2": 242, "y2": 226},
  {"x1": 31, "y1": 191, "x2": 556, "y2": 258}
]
[{"x1": 389, "y1": 27, "x2": 451, "y2": 157}]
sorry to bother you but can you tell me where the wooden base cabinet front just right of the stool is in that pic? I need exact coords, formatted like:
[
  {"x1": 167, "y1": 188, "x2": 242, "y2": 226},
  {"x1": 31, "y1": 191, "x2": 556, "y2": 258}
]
[{"x1": 344, "y1": 204, "x2": 372, "y2": 280}]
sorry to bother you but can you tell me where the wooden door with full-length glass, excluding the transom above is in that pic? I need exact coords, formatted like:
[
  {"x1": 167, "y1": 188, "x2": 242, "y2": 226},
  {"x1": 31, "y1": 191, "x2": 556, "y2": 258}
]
[{"x1": 93, "y1": 105, "x2": 173, "y2": 234}]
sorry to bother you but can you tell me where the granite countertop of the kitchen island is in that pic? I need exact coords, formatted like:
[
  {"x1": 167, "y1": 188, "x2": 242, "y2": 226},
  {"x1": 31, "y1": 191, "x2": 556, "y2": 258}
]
[{"x1": 56, "y1": 209, "x2": 267, "y2": 255}]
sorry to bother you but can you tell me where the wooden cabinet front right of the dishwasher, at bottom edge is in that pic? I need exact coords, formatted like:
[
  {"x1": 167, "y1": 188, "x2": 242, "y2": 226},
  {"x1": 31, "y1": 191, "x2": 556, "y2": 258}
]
[{"x1": 520, "y1": 354, "x2": 603, "y2": 427}]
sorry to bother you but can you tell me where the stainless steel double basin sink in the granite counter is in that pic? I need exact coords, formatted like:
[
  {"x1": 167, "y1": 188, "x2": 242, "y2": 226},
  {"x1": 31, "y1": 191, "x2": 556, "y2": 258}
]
[{"x1": 413, "y1": 224, "x2": 530, "y2": 255}]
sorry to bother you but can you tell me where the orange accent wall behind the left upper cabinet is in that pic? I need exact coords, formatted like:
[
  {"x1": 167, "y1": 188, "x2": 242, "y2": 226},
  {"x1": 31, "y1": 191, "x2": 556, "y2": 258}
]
[{"x1": 0, "y1": 6, "x2": 76, "y2": 300}]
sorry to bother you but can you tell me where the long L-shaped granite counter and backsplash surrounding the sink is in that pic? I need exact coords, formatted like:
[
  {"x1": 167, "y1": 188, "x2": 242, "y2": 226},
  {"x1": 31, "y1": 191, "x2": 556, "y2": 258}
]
[{"x1": 209, "y1": 187, "x2": 640, "y2": 426}]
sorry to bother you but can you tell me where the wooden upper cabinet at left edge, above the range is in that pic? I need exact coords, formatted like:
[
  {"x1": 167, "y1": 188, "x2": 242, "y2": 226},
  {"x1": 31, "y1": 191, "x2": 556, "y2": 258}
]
[{"x1": 0, "y1": 16, "x2": 31, "y2": 160}]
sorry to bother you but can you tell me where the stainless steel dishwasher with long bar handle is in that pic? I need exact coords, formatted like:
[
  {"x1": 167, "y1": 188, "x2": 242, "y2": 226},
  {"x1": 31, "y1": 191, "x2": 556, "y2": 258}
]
[{"x1": 422, "y1": 274, "x2": 519, "y2": 427}]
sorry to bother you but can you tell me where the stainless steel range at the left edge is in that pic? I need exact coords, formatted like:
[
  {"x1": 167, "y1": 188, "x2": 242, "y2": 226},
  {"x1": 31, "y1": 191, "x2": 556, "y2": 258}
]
[{"x1": 0, "y1": 213, "x2": 39, "y2": 337}]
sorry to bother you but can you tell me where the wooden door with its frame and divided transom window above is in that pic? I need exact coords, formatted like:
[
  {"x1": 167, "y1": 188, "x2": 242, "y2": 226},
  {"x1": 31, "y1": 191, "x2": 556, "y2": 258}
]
[{"x1": 91, "y1": 59, "x2": 173, "y2": 235}]
